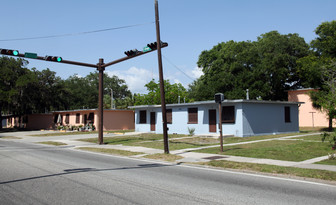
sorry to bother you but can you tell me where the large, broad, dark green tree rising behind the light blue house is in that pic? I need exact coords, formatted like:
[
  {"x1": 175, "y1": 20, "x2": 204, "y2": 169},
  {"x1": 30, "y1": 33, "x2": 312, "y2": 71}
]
[{"x1": 189, "y1": 31, "x2": 309, "y2": 100}]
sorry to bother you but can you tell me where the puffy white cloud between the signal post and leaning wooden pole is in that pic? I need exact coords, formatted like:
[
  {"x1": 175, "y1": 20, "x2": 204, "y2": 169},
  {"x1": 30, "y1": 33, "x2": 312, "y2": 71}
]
[{"x1": 106, "y1": 67, "x2": 155, "y2": 93}]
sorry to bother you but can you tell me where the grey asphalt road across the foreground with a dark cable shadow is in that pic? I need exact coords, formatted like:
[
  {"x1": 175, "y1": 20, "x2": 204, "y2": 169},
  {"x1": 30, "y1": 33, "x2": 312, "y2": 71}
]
[{"x1": 0, "y1": 139, "x2": 336, "y2": 205}]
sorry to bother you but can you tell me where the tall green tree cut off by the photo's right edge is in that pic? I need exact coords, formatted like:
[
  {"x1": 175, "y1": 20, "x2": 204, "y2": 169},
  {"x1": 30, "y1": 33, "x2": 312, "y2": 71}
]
[{"x1": 299, "y1": 21, "x2": 336, "y2": 131}]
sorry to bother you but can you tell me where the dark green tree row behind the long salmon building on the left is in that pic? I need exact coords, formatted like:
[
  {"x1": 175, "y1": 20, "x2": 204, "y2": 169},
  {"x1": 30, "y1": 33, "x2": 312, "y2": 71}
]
[{"x1": 0, "y1": 57, "x2": 133, "y2": 128}]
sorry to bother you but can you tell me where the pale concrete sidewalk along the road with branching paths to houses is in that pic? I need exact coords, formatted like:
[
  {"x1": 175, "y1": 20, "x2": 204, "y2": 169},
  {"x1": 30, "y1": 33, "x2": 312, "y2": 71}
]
[{"x1": 0, "y1": 131, "x2": 336, "y2": 172}]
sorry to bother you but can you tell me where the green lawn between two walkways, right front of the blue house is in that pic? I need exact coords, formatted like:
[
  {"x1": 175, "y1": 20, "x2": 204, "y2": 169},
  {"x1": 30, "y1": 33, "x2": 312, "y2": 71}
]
[{"x1": 197, "y1": 140, "x2": 330, "y2": 162}]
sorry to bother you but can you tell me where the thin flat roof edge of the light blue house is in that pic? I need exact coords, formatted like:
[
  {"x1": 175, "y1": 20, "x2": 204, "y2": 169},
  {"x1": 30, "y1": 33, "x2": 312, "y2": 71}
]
[{"x1": 128, "y1": 99, "x2": 304, "y2": 109}]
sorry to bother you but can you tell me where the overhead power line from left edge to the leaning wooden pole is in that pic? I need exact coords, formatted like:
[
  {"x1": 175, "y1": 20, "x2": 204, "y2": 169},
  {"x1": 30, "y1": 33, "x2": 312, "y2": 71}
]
[{"x1": 0, "y1": 22, "x2": 154, "y2": 41}]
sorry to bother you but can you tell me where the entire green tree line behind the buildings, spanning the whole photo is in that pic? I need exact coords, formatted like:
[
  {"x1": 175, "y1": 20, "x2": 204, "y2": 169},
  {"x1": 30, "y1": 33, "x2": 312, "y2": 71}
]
[{"x1": 0, "y1": 21, "x2": 336, "y2": 130}]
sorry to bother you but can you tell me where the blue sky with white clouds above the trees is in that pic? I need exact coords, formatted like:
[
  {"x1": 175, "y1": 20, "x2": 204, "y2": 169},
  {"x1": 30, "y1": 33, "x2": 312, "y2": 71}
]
[{"x1": 0, "y1": 0, "x2": 336, "y2": 93}]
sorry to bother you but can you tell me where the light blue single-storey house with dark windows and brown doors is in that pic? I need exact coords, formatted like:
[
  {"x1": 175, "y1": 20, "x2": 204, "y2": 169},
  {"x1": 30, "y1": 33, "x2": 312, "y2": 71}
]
[{"x1": 129, "y1": 100, "x2": 301, "y2": 137}]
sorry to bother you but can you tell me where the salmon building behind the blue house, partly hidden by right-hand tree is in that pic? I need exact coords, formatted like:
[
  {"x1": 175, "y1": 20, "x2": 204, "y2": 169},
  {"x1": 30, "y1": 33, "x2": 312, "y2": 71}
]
[{"x1": 288, "y1": 88, "x2": 336, "y2": 127}]
